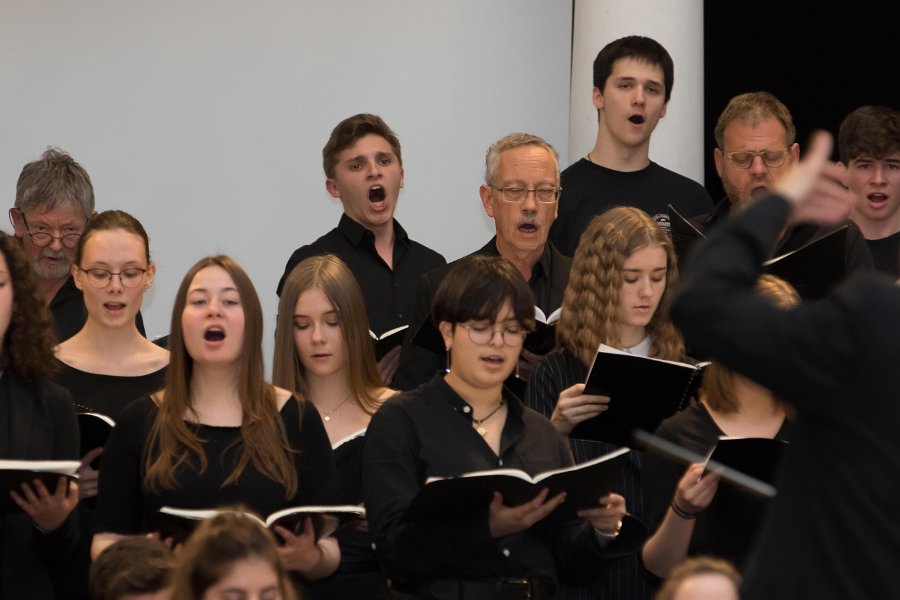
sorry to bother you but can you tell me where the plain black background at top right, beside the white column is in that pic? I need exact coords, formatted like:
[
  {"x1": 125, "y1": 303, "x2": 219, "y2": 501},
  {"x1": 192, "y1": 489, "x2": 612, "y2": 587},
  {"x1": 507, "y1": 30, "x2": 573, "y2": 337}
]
[{"x1": 704, "y1": 0, "x2": 900, "y2": 201}]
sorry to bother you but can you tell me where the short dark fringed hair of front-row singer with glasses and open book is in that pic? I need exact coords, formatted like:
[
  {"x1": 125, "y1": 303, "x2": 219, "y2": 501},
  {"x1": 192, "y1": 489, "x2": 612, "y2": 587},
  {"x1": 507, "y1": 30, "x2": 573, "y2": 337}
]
[{"x1": 432, "y1": 254, "x2": 535, "y2": 331}]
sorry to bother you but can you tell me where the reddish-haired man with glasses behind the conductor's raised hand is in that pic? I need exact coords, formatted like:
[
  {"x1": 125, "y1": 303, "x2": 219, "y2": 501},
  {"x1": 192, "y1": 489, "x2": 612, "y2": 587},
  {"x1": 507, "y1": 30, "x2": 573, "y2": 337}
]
[{"x1": 672, "y1": 92, "x2": 872, "y2": 290}]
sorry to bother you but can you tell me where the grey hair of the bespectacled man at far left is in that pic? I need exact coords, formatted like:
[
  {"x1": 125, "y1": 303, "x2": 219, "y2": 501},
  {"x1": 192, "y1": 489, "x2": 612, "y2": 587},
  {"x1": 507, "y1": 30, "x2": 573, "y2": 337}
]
[{"x1": 15, "y1": 148, "x2": 94, "y2": 221}]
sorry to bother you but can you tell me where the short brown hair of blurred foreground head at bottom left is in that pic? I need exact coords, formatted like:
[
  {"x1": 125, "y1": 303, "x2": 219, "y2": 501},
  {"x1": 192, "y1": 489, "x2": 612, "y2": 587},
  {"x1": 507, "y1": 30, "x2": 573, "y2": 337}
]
[{"x1": 90, "y1": 535, "x2": 175, "y2": 600}]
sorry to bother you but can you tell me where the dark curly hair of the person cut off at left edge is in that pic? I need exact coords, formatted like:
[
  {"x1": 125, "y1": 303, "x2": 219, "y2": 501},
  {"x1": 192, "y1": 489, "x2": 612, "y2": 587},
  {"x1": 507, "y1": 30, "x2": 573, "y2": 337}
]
[{"x1": 0, "y1": 232, "x2": 56, "y2": 381}]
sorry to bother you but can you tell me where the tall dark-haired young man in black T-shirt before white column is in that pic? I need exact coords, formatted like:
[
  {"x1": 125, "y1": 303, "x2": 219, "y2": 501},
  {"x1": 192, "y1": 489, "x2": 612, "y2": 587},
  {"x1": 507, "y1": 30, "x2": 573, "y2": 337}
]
[{"x1": 550, "y1": 35, "x2": 712, "y2": 256}]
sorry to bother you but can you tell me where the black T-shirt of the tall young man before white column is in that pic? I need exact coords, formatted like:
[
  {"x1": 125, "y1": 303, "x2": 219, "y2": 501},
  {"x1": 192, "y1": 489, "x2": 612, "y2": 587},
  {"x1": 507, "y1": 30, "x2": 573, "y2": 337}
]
[{"x1": 550, "y1": 158, "x2": 713, "y2": 256}]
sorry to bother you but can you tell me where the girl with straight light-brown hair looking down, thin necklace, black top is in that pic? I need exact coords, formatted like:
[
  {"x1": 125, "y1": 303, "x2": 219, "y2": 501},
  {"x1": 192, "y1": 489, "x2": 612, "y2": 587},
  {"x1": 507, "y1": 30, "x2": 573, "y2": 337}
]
[{"x1": 272, "y1": 254, "x2": 396, "y2": 600}]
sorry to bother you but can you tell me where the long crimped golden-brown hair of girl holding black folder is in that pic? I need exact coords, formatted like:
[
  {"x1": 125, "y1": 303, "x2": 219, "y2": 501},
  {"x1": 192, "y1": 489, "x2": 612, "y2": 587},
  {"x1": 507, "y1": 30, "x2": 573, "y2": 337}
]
[{"x1": 556, "y1": 206, "x2": 684, "y2": 365}]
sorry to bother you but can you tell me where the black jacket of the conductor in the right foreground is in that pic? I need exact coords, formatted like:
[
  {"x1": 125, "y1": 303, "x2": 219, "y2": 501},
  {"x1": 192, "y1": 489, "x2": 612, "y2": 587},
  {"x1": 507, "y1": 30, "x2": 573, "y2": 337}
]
[{"x1": 672, "y1": 197, "x2": 900, "y2": 600}]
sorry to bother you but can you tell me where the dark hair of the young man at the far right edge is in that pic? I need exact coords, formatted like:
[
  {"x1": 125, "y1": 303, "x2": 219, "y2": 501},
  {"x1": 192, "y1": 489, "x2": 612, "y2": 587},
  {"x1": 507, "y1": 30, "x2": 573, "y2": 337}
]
[{"x1": 838, "y1": 106, "x2": 900, "y2": 165}]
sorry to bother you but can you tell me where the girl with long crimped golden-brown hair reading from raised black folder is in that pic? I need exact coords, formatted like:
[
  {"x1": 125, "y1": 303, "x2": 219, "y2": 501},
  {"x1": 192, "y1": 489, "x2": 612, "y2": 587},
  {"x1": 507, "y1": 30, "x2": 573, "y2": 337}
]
[{"x1": 525, "y1": 206, "x2": 684, "y2": 598}]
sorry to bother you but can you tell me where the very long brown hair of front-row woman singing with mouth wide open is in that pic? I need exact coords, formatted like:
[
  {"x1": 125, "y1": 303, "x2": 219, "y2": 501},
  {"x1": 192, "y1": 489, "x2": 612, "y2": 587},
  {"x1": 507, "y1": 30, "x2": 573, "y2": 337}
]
[{"x1": 144, "y1": 255, "x2": 298, "y2": 499}]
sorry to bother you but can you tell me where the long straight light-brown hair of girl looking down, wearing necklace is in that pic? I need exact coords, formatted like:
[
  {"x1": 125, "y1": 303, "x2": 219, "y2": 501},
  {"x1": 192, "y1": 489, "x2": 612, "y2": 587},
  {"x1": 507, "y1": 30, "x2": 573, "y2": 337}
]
[{"x1": 272, "y1": 254, "x2": 384, "y2": 415}]
